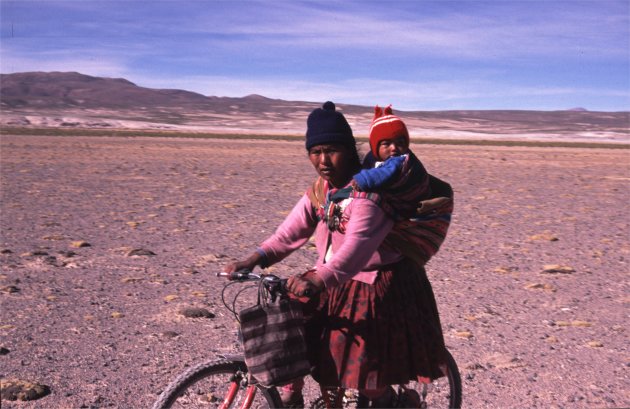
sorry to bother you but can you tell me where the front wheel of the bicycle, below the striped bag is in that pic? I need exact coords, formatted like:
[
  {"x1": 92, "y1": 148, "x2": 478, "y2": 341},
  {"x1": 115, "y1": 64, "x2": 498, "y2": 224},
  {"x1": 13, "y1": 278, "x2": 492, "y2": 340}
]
[{"x1": 153, "y1": 359, "x2": 282, "y2": 409}]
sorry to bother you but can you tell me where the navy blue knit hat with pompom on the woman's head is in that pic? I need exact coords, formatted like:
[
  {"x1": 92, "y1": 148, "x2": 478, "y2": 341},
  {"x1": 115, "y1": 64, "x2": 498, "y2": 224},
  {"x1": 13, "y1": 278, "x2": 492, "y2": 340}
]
[{"x1": 306, "y1": 101, "x2": 356, "y2": 150}]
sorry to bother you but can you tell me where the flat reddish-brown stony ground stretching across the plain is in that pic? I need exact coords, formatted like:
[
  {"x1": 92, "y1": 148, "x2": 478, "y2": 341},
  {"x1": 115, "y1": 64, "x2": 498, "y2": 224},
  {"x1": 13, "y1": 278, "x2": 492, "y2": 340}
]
[{"x1": 0, "y1": 135, "x2": 630, "y2": 408}]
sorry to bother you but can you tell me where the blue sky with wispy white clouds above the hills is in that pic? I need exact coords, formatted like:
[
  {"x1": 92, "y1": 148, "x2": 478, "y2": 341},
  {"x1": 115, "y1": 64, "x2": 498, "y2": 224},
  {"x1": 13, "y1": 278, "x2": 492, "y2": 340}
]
[{"x1": 0, "y1": 0, "x2": 630, "y2": 111}]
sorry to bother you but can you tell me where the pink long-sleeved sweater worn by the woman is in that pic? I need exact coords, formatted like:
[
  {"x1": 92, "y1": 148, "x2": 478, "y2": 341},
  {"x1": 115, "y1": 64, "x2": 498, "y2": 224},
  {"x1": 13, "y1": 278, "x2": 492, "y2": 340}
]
[{"x1": 260, "y1": 194, "x2": 402, "y2": 288}]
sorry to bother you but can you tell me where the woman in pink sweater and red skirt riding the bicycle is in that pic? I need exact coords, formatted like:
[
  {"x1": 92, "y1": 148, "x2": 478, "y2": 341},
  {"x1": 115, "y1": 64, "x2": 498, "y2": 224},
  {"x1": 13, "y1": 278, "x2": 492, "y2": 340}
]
[{"x1": 225, "y1": 102, "x2": 445, "y2": 407}]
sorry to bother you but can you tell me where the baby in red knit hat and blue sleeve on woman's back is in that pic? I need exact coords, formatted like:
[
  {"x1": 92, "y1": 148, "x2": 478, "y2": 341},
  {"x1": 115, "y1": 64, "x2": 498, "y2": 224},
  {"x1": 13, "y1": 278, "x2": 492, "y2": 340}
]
[{"x1": 353, "y1": 105, "x2": 431, "y2": 220}]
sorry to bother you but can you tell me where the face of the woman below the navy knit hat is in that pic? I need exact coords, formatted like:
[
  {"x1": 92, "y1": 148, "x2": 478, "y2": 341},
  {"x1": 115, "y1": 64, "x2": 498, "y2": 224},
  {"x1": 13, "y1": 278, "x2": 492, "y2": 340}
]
[{"x1": 308, "y1": 143, "x2": 356, "y2": 188}]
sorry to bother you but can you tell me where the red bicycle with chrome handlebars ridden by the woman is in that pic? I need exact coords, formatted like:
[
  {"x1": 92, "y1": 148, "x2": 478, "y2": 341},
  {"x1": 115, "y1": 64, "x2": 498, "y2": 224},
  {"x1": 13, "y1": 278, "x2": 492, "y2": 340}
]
[{"x1": 152, "y1": 271, "x2": 462, "y2": 409}]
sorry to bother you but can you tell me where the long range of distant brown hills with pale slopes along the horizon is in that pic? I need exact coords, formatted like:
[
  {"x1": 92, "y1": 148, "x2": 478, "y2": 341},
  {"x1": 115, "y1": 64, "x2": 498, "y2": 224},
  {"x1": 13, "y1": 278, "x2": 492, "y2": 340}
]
[{"x1": 0, "y1": 72, "x2": 630, "y2": 140}]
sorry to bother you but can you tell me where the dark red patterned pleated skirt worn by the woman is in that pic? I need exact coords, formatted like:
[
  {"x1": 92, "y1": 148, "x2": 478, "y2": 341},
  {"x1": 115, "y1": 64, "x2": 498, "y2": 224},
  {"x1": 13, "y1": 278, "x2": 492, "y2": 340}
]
[{"x1": 305, "y1": 260, "x2": 446, "y2": 389}]
